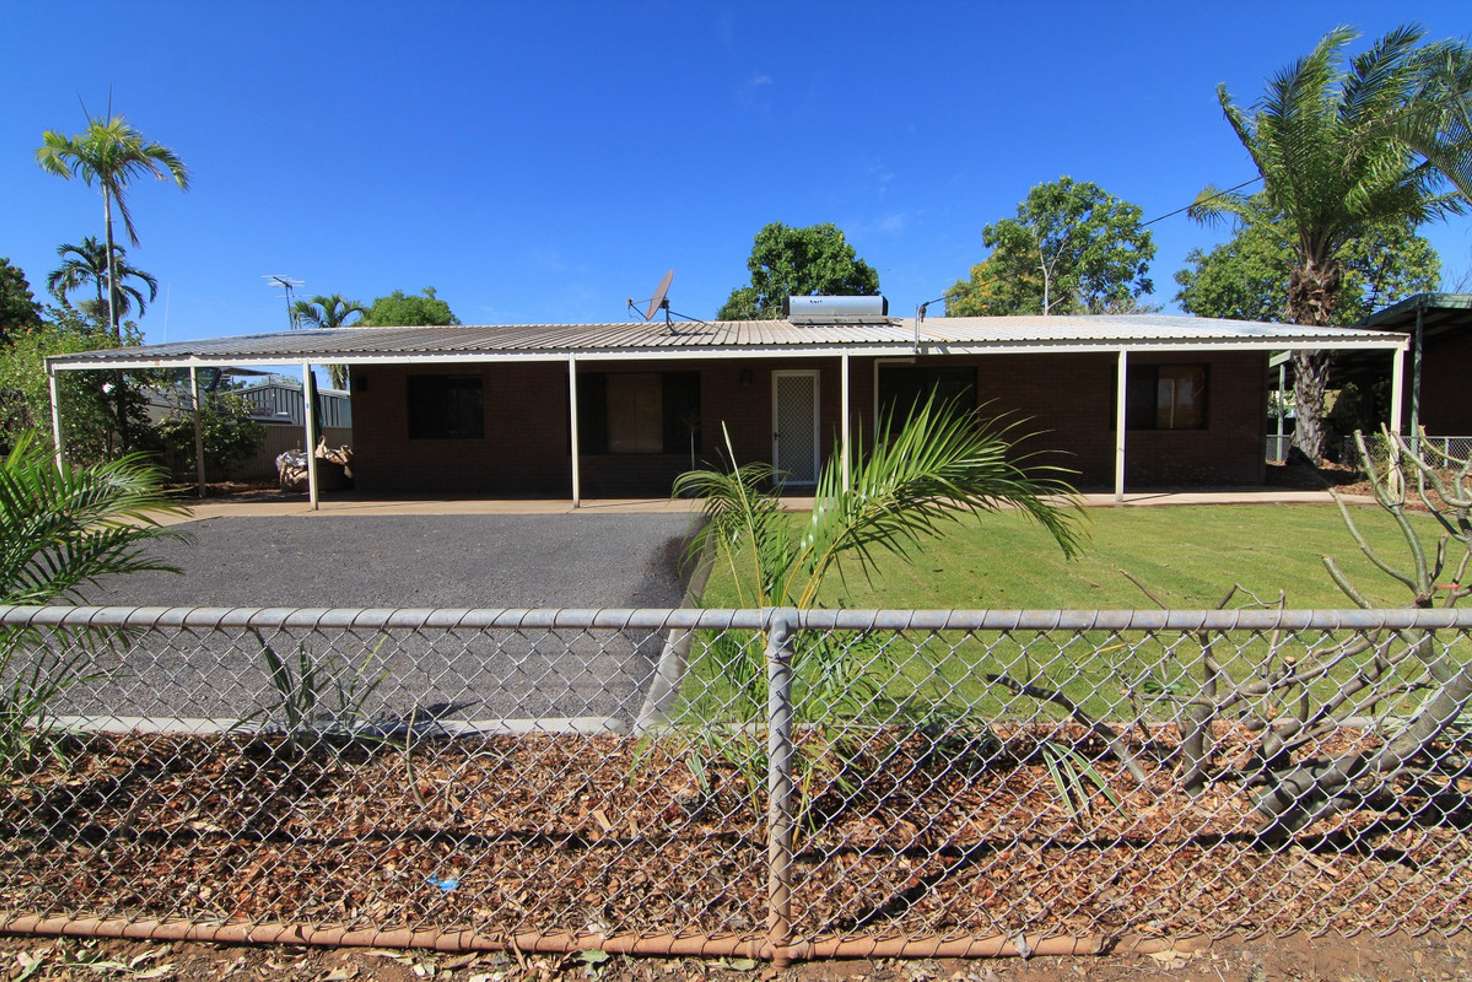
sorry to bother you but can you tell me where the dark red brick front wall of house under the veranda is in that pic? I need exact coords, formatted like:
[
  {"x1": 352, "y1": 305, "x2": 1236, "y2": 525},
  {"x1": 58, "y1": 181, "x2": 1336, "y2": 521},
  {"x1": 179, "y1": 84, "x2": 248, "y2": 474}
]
[{"x1": 352, "y1": 353, "x2": 1271, "y2": 498}]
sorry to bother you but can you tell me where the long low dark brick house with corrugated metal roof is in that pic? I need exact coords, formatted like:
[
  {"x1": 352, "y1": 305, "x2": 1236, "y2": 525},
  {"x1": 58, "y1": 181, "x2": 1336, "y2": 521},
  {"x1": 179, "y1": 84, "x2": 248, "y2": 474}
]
[{"x1": 49, "y1": 309, "x2": 1407, "y2": 502}]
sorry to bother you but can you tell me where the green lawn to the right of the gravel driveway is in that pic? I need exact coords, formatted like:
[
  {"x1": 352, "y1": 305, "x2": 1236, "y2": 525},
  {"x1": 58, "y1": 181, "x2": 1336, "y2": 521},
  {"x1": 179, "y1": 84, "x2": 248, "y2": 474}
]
[{"x1": 684, "y1": 505, "x2": 1465, "y2": 718}]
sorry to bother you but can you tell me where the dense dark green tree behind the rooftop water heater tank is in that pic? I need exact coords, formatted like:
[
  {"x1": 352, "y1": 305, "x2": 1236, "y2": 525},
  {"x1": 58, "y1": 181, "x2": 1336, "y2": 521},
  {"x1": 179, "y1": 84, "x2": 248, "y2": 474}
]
[{"x1": 715, "y1": 222, "x2": 879, "y2": 321}]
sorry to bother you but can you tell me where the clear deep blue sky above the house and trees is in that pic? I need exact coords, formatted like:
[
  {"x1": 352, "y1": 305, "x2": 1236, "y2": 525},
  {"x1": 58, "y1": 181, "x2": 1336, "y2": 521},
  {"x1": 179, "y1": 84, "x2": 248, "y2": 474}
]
[{"x1": 0, "y1": 0, "x2": 1472, "y2": 348}]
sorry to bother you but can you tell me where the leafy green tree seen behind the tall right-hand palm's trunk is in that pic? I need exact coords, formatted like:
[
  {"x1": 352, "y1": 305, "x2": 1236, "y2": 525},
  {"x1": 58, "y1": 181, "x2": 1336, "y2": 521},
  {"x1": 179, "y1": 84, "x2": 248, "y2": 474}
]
[{"x1": 1175, "y1": 206, "x2": 1441, "y2": 325}]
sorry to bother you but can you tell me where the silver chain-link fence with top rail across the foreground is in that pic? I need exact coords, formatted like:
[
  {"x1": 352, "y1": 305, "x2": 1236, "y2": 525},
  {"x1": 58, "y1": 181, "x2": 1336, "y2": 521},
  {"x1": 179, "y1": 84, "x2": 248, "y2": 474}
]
[{"x1": 0, "y1": 607, "x2": 1472, "y2": 961}]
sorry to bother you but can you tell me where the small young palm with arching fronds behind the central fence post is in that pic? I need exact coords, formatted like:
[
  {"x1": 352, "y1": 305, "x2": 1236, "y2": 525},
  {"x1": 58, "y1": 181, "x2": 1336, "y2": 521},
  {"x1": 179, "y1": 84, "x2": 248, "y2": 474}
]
[{"x1": 674, "y1": 400, "x2": 1080, "y2": 829}]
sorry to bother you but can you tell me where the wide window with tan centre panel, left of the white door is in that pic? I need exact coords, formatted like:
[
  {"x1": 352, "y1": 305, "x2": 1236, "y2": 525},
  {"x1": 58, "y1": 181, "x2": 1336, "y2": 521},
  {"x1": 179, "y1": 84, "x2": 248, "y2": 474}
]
[{"x1": 577, "y1": 371, "x2": 701, "y2": 453}]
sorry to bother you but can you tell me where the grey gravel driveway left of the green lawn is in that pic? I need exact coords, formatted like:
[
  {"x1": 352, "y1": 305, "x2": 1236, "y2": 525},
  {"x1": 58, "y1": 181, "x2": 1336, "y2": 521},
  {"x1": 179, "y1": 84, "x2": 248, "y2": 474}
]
[{"x1": 66, "y1": 514, "x2": 699, "y2": 723}]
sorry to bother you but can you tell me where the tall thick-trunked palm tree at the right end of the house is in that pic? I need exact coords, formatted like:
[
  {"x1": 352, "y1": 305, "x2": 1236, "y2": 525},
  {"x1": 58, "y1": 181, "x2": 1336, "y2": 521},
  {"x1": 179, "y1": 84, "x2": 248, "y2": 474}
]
[{"x1": 1191, "y1": 27, "x2": 1472, "y2": 461}]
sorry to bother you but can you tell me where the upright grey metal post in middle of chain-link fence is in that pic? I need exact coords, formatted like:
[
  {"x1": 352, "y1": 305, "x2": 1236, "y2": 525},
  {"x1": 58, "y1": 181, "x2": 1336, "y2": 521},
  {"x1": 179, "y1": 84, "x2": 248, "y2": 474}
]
[{"x1": 767, "y1": 611, "x2": 796, "y2": 967}]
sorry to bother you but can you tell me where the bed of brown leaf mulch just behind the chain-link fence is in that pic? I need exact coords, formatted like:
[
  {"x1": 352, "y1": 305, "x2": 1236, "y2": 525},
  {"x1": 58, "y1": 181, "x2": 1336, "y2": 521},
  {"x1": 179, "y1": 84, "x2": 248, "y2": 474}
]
[{"x1": 0, "y1": 729, "x2": 1472, "y2": 938}]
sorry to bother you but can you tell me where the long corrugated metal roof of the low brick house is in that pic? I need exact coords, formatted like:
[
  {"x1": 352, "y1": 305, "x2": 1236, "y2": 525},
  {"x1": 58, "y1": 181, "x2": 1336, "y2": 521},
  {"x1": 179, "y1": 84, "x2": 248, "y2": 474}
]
[{"x1": 49, "y1": 314, "x2": 1406, "y2": 370}]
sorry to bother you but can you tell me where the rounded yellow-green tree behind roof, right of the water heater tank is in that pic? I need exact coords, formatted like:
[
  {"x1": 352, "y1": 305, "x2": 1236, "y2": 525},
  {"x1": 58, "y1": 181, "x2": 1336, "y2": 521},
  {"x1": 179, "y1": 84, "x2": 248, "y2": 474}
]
[{"x1": 945, "y1": 177, "x2": 1156, "y2": 317}]
